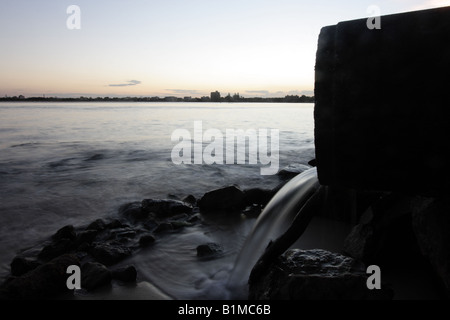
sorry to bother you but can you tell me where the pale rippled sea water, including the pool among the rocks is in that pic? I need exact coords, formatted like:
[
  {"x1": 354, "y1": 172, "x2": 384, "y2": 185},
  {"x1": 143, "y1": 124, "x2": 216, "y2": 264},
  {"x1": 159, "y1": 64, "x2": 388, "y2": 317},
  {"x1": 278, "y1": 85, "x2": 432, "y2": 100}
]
[{"x1": 0, "y1": 102, "x2": 314, "y2": 298}]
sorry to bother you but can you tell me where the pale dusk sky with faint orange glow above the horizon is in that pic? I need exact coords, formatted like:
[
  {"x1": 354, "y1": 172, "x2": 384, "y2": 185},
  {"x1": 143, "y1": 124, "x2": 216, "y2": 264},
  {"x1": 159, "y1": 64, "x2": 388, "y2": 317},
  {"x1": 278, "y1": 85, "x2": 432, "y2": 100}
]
[{"x1": 0, "y1": 0, "x2": 450, "y2": 97}]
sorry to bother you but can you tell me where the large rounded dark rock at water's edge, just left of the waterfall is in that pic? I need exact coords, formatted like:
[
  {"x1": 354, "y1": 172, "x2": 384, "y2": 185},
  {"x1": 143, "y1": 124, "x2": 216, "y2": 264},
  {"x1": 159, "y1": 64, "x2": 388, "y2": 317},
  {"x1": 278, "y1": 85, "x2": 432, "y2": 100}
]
[{"x1": 198, "y1": 186, "x2": 245, "y2": 210}]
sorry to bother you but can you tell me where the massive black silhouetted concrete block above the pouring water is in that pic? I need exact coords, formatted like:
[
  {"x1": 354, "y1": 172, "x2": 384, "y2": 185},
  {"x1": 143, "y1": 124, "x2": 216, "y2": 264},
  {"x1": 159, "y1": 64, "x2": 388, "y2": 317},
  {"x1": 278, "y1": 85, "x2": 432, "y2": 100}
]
[{"x1": 314, "y1": 7, "x2": 450, "y2": 194}]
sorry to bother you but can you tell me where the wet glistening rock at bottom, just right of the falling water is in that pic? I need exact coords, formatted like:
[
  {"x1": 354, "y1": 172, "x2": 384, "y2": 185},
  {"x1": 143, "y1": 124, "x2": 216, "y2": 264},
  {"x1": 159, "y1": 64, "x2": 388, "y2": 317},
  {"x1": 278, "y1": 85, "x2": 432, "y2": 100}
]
[{"x1": 249, "y1": 249, "x2": 393, "y2": 300}]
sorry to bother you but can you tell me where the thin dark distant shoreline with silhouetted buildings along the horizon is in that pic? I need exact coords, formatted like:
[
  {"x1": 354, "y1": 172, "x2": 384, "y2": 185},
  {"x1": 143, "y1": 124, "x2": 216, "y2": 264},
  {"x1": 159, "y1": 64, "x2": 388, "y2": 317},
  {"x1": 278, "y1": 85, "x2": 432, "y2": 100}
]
[{"x1": 0, "y1": 95, "x2": 314, "y2": 103}]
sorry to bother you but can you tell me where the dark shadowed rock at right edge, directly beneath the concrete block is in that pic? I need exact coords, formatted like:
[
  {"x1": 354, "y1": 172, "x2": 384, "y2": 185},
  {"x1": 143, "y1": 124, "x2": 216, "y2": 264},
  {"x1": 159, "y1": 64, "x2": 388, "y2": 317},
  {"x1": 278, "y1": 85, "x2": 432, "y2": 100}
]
[{"x1": 412, "y1": 197, "x2": 450, "y2": 297}]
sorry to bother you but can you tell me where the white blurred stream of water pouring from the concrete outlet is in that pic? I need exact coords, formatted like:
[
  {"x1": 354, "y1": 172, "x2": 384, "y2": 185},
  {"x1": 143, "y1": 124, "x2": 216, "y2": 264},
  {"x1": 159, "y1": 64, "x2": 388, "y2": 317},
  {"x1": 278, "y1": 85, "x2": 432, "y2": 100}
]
[{"x1": 228, "y1": 168, "x2": 320, "y2": 299}]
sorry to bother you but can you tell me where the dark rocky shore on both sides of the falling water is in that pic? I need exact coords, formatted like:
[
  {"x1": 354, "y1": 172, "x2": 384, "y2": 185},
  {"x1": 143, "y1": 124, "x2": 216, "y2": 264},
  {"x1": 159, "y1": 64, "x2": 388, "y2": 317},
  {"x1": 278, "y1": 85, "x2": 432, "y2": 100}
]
[{"x1": 0, "y1": 165, "x2": 450, "y2": 299}]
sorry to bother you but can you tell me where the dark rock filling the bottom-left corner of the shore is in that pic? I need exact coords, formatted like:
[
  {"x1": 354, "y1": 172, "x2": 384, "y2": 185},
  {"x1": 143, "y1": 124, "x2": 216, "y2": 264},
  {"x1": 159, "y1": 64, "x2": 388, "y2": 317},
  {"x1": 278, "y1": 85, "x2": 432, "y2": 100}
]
[{"x1": 0, "y1": 254, "x2": 80, "y2": 299}]
